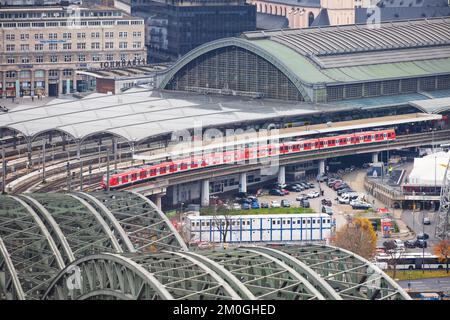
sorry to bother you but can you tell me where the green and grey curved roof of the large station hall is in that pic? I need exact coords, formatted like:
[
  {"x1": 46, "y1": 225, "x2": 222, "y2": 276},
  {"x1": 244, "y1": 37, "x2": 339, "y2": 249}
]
[{"x1": 242, "y1": 18, "x2": 450, "y2": 84}]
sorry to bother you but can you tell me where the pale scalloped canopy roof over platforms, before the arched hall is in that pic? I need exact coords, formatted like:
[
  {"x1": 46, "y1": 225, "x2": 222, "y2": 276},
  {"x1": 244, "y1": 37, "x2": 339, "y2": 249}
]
[{"x1": 0, "y1": 89, "x2": 350, "y2": 141}]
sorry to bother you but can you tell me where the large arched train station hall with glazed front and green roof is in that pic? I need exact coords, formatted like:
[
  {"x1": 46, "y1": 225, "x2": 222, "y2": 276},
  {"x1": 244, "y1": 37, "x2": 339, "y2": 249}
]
[{"x1": 160, "y1": 18, "x2": 450, "y2": 103}]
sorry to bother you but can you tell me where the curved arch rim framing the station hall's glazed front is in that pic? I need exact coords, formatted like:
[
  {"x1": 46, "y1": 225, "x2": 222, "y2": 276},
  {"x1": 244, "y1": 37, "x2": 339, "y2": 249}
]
[{"x1": 159, "y1": 38, "x2": 312, "y2": 102}]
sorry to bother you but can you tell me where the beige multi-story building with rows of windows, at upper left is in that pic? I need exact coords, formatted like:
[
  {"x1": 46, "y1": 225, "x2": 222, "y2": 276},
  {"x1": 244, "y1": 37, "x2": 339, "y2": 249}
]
[{"x1": 0, "y1": 6, "x2": 146, "y2": 97}]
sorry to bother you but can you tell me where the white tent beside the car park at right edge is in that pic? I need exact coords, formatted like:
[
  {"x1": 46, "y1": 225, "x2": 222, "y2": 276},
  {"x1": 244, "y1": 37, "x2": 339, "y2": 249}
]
[{"x1": 408, "y1": 151, "x2": 450, "y2": 186}]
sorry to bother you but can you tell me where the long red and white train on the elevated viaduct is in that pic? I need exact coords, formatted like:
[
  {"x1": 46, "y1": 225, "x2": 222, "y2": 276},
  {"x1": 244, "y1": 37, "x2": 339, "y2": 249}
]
[{"x1": 102, "y1": 129, "x2": 396, "y2": 189}]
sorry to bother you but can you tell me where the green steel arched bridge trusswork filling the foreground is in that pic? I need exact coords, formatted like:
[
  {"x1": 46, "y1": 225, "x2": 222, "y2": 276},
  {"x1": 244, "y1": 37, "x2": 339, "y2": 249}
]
[{"x1": 0, "y1": 191, "x2": 410, "y2": 300}]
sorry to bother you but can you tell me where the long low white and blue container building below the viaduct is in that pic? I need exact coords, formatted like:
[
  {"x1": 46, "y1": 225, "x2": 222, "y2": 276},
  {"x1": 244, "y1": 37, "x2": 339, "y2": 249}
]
[{"x1": 184, "y1": 213, "x2": 333, "y2": 243}]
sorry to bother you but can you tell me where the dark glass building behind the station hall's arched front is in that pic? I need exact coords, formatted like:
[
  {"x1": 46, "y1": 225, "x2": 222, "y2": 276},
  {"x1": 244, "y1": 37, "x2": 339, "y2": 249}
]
[{"x1": 131, "y1": 0, "x2": 256, "y2": 62}]
